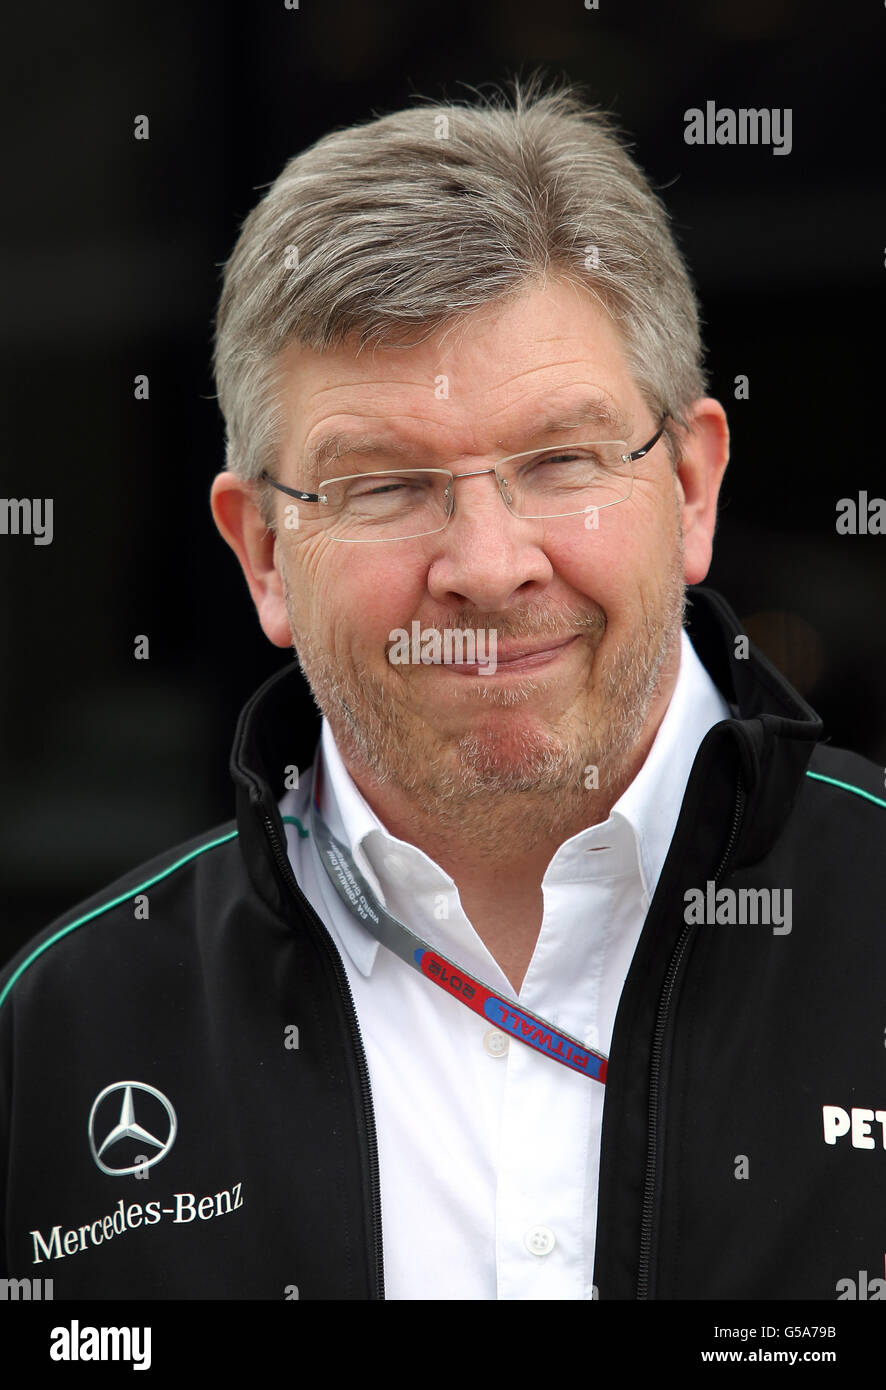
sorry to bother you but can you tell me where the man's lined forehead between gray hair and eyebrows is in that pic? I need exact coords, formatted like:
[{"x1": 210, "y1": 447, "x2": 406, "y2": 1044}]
[{"x1": 272, "y1": 281, "x2": 641, "y2": 459}]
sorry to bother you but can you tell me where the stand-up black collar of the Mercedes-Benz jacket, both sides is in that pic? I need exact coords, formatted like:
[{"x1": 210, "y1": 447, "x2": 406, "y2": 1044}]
[{"x1": 229, "y1": 588, "x2": 822, "y2": 915}]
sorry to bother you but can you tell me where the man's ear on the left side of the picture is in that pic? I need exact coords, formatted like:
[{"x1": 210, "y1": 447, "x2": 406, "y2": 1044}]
[{"x1": 210, "y1": 471, "x2": 292, "y2": 646}]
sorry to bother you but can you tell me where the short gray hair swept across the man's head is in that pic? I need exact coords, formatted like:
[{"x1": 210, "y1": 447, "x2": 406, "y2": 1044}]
[{"x1": 214, "y1": 75, "x2": 705, "y2": 524}]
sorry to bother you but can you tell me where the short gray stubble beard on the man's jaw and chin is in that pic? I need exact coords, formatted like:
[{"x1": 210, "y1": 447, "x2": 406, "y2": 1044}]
[{"x1": 282, "y1": 535, "x2": 686, "y2": 849}]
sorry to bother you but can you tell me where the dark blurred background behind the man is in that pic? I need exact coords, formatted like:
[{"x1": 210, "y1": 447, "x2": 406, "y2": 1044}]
[{"x1": 0, "y1": 0, "x2": 886, "y2": 959}]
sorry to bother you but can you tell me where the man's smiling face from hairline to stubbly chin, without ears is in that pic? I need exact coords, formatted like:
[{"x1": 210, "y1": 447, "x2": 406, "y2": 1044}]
[{"x1": 223, "y1": 272, "x2": 723, "y2": 819}]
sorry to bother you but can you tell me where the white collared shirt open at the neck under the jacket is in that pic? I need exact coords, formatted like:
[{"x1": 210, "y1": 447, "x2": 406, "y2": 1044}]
[{"x1": 280, "y1": 632, "x2": 730, "y2": 1300}]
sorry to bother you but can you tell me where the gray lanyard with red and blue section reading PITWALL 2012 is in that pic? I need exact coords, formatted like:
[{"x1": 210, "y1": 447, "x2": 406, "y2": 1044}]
[{"x1": 310, "y1": 749, "x2": 606, "y2": 1081}]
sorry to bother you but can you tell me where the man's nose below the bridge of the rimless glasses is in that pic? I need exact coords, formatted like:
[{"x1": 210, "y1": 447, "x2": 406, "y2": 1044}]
[{"x1": 428, "y1": 468, "x2": 554, "y2": 610}]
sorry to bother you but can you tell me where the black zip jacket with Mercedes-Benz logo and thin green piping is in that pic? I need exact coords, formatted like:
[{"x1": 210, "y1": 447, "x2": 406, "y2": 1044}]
[{"x1": 0, "y1": 589, "x2": 886, "y2": 1301}]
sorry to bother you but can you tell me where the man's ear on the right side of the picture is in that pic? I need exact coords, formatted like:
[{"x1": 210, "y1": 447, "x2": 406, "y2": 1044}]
[{"x1": 676, "y1": 396, "x2": 729, "y2": 584}]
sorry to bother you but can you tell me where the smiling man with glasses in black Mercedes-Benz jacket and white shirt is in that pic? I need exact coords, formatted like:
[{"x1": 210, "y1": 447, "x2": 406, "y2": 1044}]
[{"x1": 0, "y1": 78, "x2": 886, "y2": 1300}]
